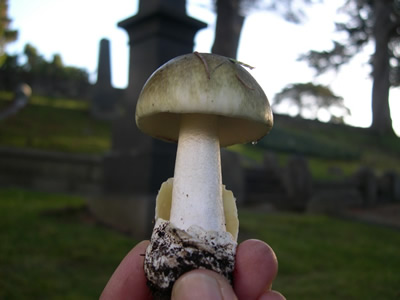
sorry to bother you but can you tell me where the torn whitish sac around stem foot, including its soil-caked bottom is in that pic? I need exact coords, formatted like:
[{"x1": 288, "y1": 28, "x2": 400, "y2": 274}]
[{"x1": 144, "y1": 178, "x2": 239, "y2": 295}]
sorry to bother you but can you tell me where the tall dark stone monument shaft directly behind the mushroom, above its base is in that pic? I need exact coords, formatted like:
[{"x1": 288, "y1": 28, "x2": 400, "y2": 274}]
[{"x1": 105, "y1": 0, "x2": 206, "y2": 194}]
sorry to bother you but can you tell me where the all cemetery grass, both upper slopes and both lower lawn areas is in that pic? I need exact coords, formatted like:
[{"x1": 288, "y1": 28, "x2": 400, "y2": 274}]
[{"x1": 0, "y1": 93, "x2": 400, "y2": 300}]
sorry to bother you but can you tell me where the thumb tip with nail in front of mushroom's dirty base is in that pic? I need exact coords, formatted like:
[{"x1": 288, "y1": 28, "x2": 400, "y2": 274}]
[{"x1": 172, "y1": 270, "x2": 237, "y2": 300}]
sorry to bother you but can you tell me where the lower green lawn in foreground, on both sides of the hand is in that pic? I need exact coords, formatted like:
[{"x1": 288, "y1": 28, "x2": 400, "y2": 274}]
[{"x1": 0, "y1": 188, "x2": 400, "y2": 300}]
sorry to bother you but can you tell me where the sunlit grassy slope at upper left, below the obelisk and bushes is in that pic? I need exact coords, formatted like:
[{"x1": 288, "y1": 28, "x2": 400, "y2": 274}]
[{"x1": 0, "y1": 92, "x2": 110, "y2": 153}]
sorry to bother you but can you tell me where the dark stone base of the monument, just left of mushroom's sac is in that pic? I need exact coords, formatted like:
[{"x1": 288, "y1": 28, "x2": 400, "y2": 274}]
[{"x1": 87, "y1": 195, "x2": 156, "y2": 240}]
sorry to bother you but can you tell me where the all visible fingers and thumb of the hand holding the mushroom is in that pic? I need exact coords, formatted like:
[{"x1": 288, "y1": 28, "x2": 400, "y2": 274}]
[{"x1": 100, "y1": 240, "x2": 285, "y2": 300}]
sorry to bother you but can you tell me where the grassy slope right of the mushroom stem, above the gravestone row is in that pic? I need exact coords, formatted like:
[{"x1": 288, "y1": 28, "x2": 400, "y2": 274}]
[{"x1": 230, "y1": 120, "x2": 400, "y2": 180}]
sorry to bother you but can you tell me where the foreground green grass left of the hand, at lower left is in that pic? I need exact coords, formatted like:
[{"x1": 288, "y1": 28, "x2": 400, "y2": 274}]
[{"x1": 0, "y1": 189, "x2": 136, "y2": 300}]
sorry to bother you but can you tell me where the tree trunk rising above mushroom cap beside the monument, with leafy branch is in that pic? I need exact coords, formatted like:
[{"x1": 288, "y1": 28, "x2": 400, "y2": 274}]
[{"x1": 212, "y1": 0, "x2": 319, "y2": 58}]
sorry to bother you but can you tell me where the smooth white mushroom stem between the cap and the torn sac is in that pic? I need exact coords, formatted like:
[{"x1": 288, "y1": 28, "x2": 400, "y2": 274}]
[{"x1": 170, "y1": 114, "x2": 226, "y2": 231}]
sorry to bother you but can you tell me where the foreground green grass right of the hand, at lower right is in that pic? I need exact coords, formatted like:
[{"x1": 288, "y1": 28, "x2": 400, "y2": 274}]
[{"x1": 240, "y1": 211, "x2": 400, "y2": 300}]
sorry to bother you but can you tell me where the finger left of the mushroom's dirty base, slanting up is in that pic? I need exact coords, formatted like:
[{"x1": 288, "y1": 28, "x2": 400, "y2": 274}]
[{"x1": 100, "y1": 241, "x2": 151, "y2": 300}]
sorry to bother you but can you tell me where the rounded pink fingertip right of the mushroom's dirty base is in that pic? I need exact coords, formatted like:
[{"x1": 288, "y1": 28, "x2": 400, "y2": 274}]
[{"x1": 234, "y1": 240, "x2": 278, "y2": 300}]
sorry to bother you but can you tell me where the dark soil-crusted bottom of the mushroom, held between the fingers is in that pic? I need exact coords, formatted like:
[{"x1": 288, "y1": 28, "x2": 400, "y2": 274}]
[{"x1": 144, "y1": 219, "x2": 236, "y2": 299}]
